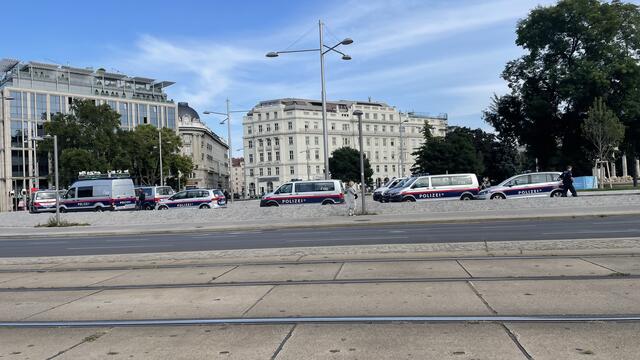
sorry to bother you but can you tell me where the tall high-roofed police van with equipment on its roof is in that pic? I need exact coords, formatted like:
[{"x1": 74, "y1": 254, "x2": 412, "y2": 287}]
[{"x1": 60, "y1": 173, "x2": 136, "y2": 212}]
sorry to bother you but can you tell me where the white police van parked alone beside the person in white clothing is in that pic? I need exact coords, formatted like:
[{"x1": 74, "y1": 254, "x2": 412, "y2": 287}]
[{"x1": 260, "y1": 180, "x2": 344, "y2": 207}]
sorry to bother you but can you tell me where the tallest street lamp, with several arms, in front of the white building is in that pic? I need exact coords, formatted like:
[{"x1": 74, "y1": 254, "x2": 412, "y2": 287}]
[{"x1": 266, "y1": 20, "x2": 353, "y2": 180}]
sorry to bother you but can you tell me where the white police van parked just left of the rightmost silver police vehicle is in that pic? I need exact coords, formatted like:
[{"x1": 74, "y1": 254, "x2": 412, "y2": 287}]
[{"x1": 388, "y1": 174, "x2": 480, "y2": 202}]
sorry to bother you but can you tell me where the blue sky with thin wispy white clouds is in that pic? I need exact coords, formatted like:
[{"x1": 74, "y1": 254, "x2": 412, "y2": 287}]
[{"x1": 0, "y1": 0, "x2": 568, "y2": 155}]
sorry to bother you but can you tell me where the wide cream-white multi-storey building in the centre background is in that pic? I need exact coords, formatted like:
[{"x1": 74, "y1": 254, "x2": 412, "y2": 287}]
[{"x1": 243, "y1": 98, "x2": 447, "y2": 196}]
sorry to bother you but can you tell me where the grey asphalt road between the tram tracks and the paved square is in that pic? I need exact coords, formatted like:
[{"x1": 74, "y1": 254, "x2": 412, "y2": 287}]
[{"x1": 0, "y1": 216, "x2": 640, "y2": 257}]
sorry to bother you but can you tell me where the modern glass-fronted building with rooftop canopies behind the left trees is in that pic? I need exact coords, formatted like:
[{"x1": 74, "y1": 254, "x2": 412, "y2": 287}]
[{"x1": 0, "y1": 59, "x2": 177, "y2": 211}]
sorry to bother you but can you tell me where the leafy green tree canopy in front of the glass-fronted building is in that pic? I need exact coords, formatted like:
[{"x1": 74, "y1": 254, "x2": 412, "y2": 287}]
[{"x1": 38, "y1": 100, "x2": 193, "y2": 186}]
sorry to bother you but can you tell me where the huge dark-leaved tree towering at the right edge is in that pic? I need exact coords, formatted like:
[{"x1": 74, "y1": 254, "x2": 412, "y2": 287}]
[{"x1": 484, "y1": 0, "x2": 640, "y2": 172}]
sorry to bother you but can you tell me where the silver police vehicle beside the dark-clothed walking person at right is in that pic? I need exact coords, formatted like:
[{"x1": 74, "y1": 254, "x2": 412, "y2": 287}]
[{"x1": 477, "y1": 171, "x2": 562, "y2": 200}]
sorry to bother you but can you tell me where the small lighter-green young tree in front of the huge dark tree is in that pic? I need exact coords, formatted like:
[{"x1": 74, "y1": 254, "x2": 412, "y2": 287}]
[{"x1": 581, "y1": 98, "x2": 624, "y2": 183}]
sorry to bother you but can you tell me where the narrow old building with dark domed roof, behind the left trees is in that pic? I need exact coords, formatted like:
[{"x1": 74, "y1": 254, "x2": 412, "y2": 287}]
[{"x1": 178, "y1": 102, "x2": 229, "y2": 190}]
